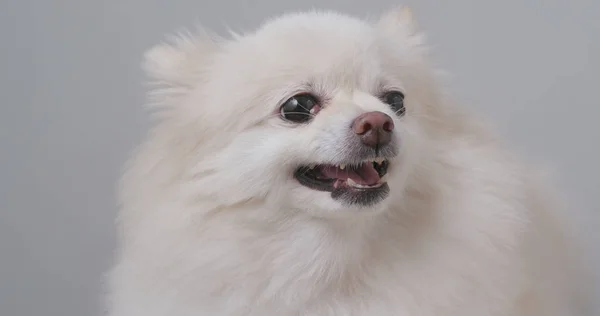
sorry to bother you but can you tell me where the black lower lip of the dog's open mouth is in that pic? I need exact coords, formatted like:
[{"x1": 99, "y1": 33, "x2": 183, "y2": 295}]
[{"x1": 294, "y1": 161, "x2": 390, "y2": 206}]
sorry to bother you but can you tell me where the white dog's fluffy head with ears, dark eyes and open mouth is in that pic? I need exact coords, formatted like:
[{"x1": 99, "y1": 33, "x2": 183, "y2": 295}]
[{"x1": 147, "y1": 10, "x2": 433, "y2": 216}]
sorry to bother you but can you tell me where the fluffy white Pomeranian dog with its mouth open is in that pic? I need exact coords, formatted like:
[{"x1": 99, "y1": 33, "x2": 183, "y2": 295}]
[{"x1": 109, "y1": 8, "x2": 588, "y2": 316}]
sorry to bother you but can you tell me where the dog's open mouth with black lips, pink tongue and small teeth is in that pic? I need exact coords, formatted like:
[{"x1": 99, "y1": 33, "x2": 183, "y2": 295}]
[{"x1": 294, "y1": 158, "x2": 389, "y2": 205}]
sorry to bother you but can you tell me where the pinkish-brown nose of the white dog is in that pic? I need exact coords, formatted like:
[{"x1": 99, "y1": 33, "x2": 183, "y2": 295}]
[{"x1": 352, "y1": 111, "x2": 394, "y2": 148}]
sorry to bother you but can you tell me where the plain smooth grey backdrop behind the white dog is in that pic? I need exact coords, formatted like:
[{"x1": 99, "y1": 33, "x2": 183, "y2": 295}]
[{"x1": 0, "y1": 0, "x2": 600, "y2": 316}]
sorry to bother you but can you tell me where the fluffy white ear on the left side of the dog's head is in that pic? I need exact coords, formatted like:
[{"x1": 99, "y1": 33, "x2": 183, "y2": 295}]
[{"x1": 142, "y1": 28, "x2": 219, "y2": 86}]
